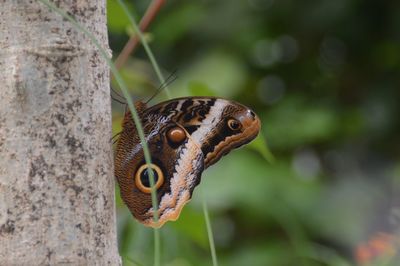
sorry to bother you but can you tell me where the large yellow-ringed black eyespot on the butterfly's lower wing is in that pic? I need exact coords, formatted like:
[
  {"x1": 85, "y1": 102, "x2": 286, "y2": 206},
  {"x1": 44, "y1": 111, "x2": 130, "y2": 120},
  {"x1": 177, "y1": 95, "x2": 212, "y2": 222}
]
[{"x1": 135, "y1": 163, "x2": 164, "y2": 193}]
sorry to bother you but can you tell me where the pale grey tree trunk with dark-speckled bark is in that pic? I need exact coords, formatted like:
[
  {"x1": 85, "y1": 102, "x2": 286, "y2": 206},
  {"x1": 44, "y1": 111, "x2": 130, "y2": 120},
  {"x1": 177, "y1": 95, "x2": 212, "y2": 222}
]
[{"x1": 0, "y1": 0, "x2": 120, "y2": 265}]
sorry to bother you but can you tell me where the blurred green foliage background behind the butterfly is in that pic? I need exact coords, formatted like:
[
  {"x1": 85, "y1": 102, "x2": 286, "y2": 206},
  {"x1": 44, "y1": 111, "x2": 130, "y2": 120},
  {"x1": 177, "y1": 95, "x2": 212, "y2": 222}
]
[{"x1": 108, "y1": 0, "x2": 400, "y2": 266}]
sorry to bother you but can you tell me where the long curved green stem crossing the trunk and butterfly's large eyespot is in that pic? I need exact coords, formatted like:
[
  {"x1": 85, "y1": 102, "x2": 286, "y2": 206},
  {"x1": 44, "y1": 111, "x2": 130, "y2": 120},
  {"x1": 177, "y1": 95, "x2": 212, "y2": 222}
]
[{"x1": 39, "y1": 0, "x2": 160, "y2": 266}]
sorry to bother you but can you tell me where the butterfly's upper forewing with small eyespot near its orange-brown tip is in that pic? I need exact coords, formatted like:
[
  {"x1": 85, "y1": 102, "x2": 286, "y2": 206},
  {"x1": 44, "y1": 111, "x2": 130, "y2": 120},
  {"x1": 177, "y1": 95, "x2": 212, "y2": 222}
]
[{"x1": 156, "y1": 97, "x2": 261, "y2": 168}]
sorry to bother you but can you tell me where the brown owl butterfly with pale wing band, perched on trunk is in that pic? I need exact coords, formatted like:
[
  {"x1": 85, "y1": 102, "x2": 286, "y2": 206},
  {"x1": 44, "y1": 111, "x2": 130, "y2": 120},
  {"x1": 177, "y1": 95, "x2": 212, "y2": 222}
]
[{"x1": 115, "y1": 97, "x2": 260, "y2": 227}]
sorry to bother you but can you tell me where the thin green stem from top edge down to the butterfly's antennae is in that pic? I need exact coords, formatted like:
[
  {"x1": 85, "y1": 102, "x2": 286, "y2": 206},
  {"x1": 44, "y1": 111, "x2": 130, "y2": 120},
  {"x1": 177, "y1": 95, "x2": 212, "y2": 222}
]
[{"x1": 118, "y1": 0, "x2": 171, "y2": 99}]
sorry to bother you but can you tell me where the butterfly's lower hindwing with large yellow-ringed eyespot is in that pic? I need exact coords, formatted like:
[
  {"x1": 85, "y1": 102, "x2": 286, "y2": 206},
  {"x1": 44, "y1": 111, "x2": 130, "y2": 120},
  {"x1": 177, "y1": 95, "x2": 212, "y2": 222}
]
[{"x1": 115, "y1": 103, "x2": 204, "y2": 227}]
